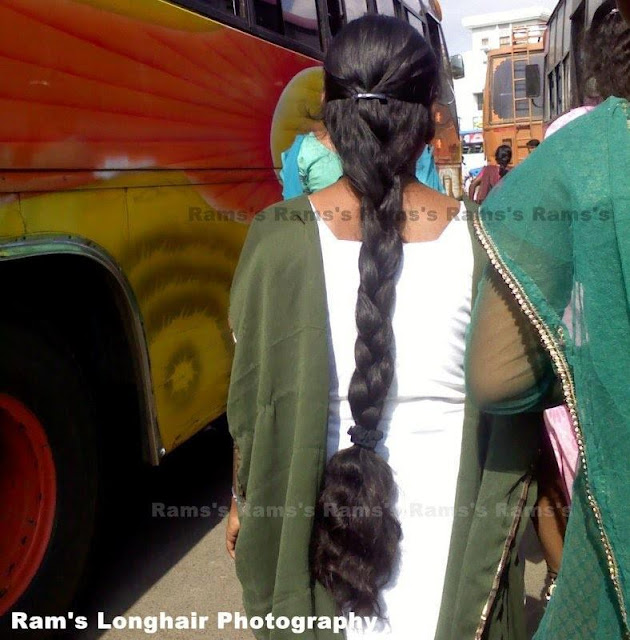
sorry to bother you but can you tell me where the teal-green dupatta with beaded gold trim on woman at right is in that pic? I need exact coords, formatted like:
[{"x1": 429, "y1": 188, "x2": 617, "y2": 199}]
[{"x1": 476, "y1": 98, "x2": 630, "y2": 640}]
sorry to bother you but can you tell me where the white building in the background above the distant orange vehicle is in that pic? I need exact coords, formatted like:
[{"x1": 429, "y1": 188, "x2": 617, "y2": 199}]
[{"x1": 455, "y1": 6, "x2": 551, "y2": 133}]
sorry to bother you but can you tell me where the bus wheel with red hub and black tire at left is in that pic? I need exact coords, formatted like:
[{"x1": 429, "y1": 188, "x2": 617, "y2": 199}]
[{"x1": 0, "y1": 325, "x2": 97, "y2": 628}]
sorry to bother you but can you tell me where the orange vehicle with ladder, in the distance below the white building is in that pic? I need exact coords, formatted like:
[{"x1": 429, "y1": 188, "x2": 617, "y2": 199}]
[{"x1": 483, "y1": 25, "x2": 546, "y2": 164}]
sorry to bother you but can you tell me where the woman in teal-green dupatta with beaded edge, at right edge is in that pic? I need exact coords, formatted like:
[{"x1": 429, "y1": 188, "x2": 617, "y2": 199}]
[{"x1": 467, "y1": 0, "x2": 630, "y2": 640}]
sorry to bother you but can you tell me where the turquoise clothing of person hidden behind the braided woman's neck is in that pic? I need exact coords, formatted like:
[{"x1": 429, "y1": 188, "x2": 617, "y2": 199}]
[{"x1": 280, "y1": 133, "x2": 446, "y2": 200}]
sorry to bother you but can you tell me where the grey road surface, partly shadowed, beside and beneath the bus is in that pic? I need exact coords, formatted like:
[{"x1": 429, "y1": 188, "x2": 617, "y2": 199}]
[{"x1": 40, "y1": 420, "x2": 544, "y2": 640}]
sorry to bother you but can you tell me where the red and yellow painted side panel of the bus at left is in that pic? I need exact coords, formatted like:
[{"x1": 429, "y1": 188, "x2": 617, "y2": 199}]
[{"x1": 0, "y1": 0, "x2": 321, "y2": 451}]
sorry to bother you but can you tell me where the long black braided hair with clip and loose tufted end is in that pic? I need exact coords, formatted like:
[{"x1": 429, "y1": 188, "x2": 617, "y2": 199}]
[{"x1": 311, "y1": 15, "x2": 439, "y2": 615}]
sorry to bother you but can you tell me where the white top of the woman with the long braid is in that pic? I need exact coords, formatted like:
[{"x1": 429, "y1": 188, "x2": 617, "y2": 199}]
[{"x1": 318, "y1": 199, "x2": 473, "y2": 640}]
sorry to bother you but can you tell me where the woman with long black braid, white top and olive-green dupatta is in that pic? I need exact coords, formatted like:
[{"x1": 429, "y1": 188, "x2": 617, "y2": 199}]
[{"x1": 227, "y1": 16, "x2": 538, "y2": 640}]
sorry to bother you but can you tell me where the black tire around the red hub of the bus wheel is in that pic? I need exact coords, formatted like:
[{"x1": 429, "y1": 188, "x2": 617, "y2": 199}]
[{"x1": 0, "y1": 323, "x2": 98, "y2": 638}]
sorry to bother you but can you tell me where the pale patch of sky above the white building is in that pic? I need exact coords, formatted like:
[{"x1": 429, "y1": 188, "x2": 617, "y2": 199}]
[{"x1": 440, "y1": 0, "x2": 557, "y2": 55}]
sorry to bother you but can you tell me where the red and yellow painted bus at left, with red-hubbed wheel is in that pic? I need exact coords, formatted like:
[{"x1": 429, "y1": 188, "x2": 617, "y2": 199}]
[{"x1": 0, "y1": 0, "x2": 461, "y2": 615}]
